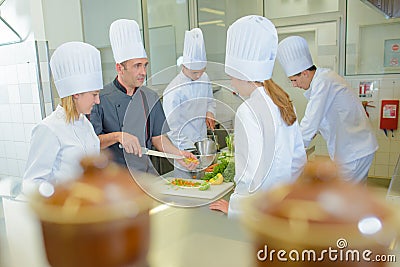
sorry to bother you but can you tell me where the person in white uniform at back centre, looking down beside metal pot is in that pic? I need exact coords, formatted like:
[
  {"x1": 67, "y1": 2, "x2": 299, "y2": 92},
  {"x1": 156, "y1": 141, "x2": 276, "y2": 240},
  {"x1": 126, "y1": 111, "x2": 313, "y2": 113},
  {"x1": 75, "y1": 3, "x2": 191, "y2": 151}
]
[{"x1": 163, "y1": 28, "x2": 215, "y2": 152}]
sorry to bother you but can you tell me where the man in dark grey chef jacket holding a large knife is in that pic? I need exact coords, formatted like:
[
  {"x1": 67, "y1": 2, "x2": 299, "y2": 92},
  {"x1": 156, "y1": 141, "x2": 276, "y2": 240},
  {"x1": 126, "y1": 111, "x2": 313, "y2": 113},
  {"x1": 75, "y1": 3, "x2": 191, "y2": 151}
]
[{"x1": 90, "y1": 19, "x2": 195, "y2": 173}]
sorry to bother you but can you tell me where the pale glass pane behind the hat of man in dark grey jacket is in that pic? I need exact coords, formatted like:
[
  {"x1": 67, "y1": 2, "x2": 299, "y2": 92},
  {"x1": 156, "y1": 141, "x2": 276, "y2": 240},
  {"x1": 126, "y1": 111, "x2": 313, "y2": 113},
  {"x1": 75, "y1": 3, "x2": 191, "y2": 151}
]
[{"x1": 81, "y1": 0, "x2": 143, "y2": 84}]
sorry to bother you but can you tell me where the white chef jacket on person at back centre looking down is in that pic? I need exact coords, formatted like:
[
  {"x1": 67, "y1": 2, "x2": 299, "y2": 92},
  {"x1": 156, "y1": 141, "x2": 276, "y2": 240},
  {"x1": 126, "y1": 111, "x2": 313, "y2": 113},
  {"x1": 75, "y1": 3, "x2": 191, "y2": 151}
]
[{"x1": 163, "y1": 71, "x2": 216, "y2": 149}]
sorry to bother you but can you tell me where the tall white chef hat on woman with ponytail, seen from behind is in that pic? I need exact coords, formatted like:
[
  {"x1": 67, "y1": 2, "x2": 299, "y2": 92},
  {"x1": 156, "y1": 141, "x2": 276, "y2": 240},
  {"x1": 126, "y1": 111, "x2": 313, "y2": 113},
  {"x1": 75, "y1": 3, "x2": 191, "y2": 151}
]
[{"x1": 225, "y1": 15, "x2": 278, "y2": 81}]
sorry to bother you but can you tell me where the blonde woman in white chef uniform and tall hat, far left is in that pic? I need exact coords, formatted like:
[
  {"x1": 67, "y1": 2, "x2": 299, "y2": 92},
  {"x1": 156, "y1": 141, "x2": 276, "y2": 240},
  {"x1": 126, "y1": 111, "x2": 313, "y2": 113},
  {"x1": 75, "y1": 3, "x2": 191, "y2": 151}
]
[{"x1": 23, "y1": 42, "x2": 103, "y2": 190}]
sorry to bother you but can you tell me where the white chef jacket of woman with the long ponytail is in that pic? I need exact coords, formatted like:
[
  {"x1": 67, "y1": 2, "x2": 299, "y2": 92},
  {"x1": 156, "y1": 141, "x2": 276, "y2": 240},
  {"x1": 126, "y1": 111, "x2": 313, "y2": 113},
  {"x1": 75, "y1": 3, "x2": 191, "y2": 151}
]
[{"x1": 228, "y1": 87, "x2": 307, "y2": 218}]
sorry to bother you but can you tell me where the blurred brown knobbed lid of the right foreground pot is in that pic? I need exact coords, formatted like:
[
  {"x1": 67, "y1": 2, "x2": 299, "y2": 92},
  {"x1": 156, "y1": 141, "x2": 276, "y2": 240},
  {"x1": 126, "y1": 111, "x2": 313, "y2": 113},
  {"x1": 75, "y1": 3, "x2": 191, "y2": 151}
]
[{"x1": 244, "y1": 161, "x2": 399, "y2": 248}]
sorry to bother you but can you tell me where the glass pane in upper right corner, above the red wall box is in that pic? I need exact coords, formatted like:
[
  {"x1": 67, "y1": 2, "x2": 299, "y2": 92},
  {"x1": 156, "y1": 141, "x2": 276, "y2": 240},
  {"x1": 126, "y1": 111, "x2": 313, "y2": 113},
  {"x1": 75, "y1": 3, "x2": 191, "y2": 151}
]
[{"x1": 346, "y1": 1, "x2": 400, "y2": 75}]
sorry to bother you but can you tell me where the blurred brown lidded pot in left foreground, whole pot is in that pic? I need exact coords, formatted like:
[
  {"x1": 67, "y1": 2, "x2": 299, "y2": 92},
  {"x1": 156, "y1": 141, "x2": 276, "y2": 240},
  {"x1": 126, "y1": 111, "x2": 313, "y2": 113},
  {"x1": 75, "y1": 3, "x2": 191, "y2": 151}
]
[{"x1": 32, "y1": 155, "x2": 150, "y2": 267}]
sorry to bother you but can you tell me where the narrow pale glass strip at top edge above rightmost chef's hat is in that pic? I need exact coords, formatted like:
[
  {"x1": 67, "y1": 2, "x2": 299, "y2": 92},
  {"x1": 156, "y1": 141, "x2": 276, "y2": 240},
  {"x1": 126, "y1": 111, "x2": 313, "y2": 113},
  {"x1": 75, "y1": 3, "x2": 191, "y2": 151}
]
[{"x1": 265, "y1": 0, "x2": 339, "y2": 19}]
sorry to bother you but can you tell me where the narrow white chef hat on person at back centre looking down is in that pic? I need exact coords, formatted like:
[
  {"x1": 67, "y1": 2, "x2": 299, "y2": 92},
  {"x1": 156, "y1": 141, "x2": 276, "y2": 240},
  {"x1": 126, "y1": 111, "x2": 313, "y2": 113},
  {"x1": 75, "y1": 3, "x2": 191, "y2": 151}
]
[{"x1": 182, "y1": 28, "x2": 207, "y2": 70}]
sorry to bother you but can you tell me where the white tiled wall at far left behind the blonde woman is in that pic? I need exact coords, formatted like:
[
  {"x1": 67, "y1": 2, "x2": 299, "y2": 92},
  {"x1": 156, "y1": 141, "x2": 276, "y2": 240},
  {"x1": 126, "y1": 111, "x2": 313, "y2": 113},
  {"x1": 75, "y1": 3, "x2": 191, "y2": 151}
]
[{"x1": 0, "y1": 40, "x2": 51, "y2": 182}]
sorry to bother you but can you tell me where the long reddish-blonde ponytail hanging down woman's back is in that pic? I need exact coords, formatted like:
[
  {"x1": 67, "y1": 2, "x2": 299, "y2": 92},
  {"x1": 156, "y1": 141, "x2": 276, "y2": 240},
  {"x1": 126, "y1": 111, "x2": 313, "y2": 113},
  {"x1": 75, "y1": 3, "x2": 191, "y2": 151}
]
[{"x1": 263, "y1": 79, "x2": 297, "y2": 126}]
